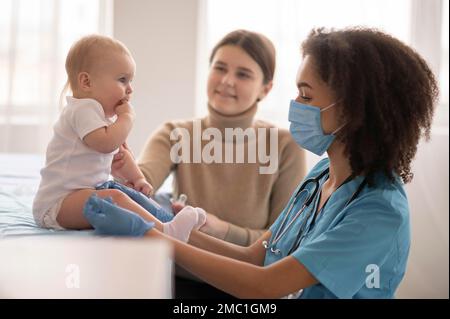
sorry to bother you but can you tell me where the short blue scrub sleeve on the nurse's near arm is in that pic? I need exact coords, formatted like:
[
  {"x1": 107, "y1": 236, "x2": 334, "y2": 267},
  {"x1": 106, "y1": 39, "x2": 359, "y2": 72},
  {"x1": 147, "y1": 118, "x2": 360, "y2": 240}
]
[{"x1": 293, "y1": 193, "x2": 408, "y2": 298}]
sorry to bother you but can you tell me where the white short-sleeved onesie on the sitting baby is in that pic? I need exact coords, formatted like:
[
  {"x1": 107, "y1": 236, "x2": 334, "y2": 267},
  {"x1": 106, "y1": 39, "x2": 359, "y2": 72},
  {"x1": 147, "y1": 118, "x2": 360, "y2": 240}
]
[{"x1": 33, "y1": 97, "x2": 118, "y2": 229}]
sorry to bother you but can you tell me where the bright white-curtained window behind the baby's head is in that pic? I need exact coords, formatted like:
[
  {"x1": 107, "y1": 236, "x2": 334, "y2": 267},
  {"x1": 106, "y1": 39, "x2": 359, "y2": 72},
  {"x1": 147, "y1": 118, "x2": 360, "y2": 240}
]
[{"x1": 0, "y1": 0, "x2": 110, "y2": 153}]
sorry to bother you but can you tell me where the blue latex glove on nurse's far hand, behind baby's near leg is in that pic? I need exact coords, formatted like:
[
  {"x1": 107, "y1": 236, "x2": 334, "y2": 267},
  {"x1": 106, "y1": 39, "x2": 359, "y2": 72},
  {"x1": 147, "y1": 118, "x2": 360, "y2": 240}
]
[{"x1": 96, "y1": 181, "x2": 173, "y2": 223}]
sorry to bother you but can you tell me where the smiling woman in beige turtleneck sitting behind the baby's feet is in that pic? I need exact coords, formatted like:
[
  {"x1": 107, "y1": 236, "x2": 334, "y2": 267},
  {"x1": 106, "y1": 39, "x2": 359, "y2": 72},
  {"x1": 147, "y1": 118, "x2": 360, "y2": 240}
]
[{"x1": 138, "y1": 30, "x2": 306, "y2": 246}]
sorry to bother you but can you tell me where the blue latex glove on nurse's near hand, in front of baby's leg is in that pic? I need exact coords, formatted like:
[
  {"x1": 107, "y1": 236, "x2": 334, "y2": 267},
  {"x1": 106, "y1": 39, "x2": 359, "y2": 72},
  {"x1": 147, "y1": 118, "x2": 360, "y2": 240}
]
[{"x1": 83, "y1": 194, "x2": 155, "y2": 237}]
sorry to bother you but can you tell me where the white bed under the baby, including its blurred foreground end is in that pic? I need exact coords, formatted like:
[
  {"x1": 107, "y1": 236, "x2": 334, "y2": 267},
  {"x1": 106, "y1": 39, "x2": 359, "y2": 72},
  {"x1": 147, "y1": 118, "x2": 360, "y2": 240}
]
[{"x1": 0, "y1": 153, "x2": 172, "y2": 298}]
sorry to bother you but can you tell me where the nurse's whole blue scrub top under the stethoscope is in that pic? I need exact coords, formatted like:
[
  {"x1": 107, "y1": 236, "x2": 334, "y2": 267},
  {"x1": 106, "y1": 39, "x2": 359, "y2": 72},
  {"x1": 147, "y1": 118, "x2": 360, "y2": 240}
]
[{"x1": 264, "y1": 159, "x2": 410, "y2": 298}]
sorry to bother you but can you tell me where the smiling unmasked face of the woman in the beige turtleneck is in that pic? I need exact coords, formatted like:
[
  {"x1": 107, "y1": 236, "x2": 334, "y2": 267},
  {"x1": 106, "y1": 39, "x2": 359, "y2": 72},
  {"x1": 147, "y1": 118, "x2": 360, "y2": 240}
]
[{"x1": 207, "y1": 45, "x2": 272, "y2": 115}]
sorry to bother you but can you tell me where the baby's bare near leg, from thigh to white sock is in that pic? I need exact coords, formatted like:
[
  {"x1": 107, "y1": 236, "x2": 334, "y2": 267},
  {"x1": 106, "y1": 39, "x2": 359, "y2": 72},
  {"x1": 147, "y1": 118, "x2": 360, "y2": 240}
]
[{"x1": 56, "y1": 189, "x2": 163, "y2": 231}]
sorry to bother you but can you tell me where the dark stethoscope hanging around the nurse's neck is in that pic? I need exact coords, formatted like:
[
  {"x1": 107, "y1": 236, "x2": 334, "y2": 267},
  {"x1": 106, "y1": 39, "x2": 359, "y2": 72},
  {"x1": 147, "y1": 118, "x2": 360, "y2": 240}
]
[{"x1": 262, "y1": 168, "x2": 367, "y2": 255}]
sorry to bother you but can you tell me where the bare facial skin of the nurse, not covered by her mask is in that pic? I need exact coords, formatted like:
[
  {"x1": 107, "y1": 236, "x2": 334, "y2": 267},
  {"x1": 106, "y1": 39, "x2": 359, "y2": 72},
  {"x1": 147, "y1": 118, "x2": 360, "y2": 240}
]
[{"x1": 295, "y1": 55, "x2": 341, "y2": 134}]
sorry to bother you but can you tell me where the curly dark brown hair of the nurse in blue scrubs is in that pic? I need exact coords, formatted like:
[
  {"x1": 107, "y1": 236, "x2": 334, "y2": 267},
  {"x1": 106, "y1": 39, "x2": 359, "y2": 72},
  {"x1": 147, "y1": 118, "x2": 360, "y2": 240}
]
[{"x1": 302, "y1": 27, "x2": 439, "y2": 184}]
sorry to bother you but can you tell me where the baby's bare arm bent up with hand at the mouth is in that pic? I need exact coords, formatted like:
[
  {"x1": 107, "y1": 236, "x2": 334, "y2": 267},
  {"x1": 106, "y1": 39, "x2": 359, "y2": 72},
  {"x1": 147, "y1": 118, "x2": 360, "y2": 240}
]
[{"x1": 83, "y1": 101, "x2": 134, "y2": 153}]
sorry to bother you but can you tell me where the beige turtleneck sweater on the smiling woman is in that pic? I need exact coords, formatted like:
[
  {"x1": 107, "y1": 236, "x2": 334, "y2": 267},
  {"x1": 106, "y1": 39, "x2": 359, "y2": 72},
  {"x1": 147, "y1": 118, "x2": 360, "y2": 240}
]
[{"x1": 138, "y1": 105, "x2": 306, "y2": 246}]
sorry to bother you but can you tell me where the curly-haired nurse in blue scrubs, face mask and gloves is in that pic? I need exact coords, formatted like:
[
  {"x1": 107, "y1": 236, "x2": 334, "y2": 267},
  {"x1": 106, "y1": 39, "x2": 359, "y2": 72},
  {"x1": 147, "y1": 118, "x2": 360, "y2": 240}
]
[{"x1": 82, "y1": 28, "x2": 438, "y2": 298}]
